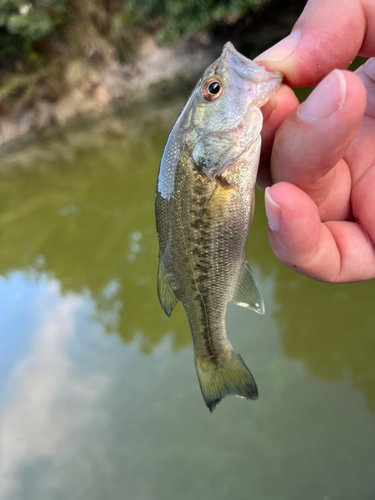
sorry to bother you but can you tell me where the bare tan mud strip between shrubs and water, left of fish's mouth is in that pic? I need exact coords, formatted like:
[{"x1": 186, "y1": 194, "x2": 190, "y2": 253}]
[{"x1": 0, "y1": 37, "x2": 221, "y2": 149}]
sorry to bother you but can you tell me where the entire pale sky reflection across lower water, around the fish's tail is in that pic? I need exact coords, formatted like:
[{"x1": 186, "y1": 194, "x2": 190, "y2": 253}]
[{"x1": 0, "y1": 269, "x2": 375, "y2": 500}]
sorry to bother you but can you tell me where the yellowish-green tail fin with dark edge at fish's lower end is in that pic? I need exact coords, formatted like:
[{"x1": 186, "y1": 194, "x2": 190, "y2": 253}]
[{"x1": 195, "y1": 350, "x2": 258, "y2": 412}]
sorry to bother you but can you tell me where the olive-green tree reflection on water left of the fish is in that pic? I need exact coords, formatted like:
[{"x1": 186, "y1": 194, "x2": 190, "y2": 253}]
[{"x1": 0, "y1": 98, "x2": 190, "y2": 351}]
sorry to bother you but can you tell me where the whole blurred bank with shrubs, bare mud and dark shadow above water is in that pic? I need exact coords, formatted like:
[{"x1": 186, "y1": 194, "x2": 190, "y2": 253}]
[{"x1": 0, "y1": 0, "x2": 306, "y2": 149}]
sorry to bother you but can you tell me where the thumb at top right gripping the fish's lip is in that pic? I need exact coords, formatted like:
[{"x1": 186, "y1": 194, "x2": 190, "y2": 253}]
[{"x1": 256, "y1": 0, "x2": 375, "y2": 87}]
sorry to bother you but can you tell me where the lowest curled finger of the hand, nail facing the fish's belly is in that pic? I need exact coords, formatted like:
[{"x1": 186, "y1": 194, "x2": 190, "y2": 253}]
[{"x1": 265, "y1": 182, "x2": 375, "y2": 283}]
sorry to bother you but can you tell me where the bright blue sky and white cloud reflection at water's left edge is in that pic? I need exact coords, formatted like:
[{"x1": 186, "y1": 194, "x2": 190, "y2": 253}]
[{"x1": 0, "y1": 273, "x2": 107, "y2": 498}]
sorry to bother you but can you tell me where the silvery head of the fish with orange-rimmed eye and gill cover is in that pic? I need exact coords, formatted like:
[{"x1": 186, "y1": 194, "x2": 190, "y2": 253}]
[{"x1": 185, "y1": 42, "x2": 282, "y2": 178}]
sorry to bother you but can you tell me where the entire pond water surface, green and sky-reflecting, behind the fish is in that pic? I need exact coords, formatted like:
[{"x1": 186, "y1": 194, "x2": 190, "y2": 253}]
[{"x1": 0, "y1": 94, "x2": 375, "y2": 500}]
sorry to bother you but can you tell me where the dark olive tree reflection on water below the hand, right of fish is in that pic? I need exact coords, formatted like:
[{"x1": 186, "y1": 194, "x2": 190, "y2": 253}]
[{"x1": 254, "y1": 196, "x2": 375, "y2": 412}]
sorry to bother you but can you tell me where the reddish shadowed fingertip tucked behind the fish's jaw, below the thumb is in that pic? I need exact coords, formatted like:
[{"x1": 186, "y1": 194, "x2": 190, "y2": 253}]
[{"x1": 257, "y1": 85, "x2": 298, "y2": 191}]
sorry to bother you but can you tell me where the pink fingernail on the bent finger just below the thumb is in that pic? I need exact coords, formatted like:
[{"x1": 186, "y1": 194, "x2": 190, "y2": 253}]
[{"x1": 298, "y1": 69, "x2": 346, "y2": 123}]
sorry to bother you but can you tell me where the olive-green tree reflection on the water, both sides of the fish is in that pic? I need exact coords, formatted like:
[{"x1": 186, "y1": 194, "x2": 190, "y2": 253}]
[{"x1": 0, "y1": 99, "x2": 375, "y2": 411}]
